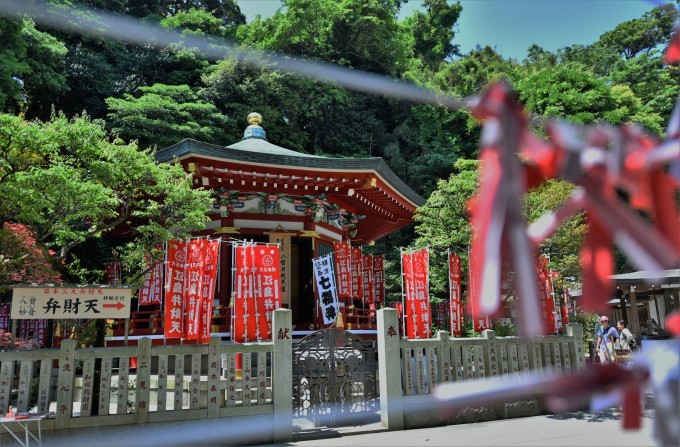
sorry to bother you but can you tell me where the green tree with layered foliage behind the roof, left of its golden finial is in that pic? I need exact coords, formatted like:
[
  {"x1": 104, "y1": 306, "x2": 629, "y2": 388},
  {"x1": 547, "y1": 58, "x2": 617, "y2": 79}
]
[{"x1": 106, "y1": 84, "x2": 236, "y2": 148}]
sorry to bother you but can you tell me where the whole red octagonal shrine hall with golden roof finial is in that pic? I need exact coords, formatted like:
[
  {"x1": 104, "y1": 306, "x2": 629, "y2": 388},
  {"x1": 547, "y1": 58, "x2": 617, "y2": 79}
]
[{"x1": 114, "y1": 113, "x2": 425, "y2": 339}]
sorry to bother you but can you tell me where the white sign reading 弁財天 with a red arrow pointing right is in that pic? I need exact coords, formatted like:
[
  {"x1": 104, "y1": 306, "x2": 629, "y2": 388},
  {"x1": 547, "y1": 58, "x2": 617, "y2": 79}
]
[{"x1": 11, "y1": 287, "x2": 132, "y2": 320}]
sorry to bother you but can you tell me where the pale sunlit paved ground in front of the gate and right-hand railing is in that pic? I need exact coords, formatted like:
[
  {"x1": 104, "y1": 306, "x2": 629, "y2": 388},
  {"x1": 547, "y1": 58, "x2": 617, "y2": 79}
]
[{"x1": 274, "y1": 410, "x2": 657, "y2": 447}]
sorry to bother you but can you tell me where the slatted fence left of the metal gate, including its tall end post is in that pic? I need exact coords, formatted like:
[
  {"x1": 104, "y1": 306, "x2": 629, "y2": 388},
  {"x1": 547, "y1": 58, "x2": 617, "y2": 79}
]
[{"x1": 0, "y1": 309, "x2": 292, "y2": 442}]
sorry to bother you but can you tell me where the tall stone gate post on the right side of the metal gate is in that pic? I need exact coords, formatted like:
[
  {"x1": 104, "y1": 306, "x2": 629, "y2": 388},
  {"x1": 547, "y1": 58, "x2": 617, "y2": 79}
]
[{"x1": 378, "y1": 307, "x2": 404, "y2": 430}]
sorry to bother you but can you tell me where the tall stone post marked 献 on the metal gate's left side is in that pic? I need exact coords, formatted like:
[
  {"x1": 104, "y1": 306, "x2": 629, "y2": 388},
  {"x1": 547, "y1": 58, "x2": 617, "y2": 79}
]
[{"x1": 272, "y1": 309, "x2": 293, "y2": 443}]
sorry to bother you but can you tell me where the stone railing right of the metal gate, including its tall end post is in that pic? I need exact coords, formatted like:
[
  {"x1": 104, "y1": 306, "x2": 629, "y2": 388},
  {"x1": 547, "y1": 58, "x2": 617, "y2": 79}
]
[{"x1": 378, "y1": 308, "x2": 585, "y2": 430}]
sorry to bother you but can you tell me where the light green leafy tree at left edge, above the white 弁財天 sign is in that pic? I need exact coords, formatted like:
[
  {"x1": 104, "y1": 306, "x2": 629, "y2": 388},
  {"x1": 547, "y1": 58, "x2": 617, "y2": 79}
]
[{"x1": 0, "y1": 114, "x2": 210, "y2": 270}]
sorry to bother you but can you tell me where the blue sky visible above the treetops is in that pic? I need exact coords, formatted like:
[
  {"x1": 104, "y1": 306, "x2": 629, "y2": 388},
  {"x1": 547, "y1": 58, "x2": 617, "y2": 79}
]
[{"x1": 237, "y1": 0, "x2": 668, "y2": 60}]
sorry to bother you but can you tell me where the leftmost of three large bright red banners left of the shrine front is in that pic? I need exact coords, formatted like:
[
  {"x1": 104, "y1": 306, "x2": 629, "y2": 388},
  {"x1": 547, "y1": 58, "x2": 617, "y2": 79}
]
[{"x1": 164, "y1": 240, "x2": 187, "y2": 338}]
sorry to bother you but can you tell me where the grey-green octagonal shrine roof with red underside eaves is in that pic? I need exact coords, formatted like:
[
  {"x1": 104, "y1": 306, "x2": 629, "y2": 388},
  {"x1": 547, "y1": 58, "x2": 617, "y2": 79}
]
[{"x1": 156, "y1": 118, "x2": 425, "y2": 243}]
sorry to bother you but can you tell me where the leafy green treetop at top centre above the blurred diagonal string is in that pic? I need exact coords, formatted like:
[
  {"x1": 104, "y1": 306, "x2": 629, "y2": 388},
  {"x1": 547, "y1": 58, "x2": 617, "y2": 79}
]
[{"x1": 238, "y1": 0, "x2": 412, "y2": 75}]
